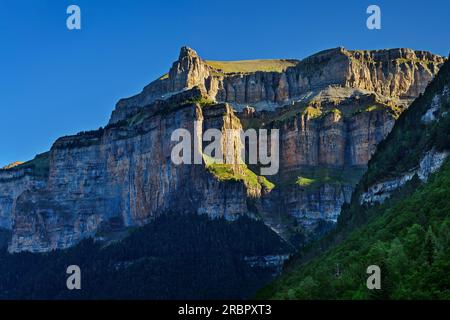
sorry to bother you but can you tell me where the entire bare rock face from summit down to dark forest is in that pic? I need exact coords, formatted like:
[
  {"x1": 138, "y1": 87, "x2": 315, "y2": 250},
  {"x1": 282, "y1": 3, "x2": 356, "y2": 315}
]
[{"x1": 0, "y1": 48, "x2": 444, "y2": 252}]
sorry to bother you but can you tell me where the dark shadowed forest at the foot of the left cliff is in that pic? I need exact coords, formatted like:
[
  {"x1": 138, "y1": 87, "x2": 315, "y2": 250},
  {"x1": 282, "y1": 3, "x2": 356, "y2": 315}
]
[{"x1": 0, "y1": 214, "x2": 291, "y2": 300}]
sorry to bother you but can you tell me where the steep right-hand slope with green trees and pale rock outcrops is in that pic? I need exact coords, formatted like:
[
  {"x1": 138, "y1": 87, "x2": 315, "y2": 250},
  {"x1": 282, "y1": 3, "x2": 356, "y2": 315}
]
[{"x1": 258, "y1": 56, "x2": 450, "y2": 299}]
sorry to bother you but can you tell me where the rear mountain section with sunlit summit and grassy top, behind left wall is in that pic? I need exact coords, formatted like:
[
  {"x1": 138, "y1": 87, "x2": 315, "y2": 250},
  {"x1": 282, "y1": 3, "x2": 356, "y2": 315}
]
[{"x1": 110, "y1": 47, "x2": 444, "y2": 243}]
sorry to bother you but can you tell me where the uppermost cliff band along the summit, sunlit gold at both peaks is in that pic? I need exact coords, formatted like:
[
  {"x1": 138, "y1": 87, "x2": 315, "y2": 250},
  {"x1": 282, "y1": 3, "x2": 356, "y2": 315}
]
[{"x1": 110, "y1": 47, "x2": 444, "y2": 123}]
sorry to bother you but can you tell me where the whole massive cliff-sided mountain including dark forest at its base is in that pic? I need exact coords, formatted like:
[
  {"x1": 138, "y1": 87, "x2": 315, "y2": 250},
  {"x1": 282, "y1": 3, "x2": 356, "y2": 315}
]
[{"x1": 0, "y1": 47, "x2": 446, "y2": 299}]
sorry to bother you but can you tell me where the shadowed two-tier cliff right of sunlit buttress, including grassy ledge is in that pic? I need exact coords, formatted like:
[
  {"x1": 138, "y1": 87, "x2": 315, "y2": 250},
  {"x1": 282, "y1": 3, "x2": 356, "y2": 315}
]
[{"x1": 281, "y1": 111, "x2": 394, "y2": 228}]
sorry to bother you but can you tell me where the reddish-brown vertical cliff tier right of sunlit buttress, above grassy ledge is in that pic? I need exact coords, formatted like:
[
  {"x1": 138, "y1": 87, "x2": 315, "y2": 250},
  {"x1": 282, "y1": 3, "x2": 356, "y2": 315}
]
[{"x1": 274, "y1": 104, "x2": 395, "y2": 171}]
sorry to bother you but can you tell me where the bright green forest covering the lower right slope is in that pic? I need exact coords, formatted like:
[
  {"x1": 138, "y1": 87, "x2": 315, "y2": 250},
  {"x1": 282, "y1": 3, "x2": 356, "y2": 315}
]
[{"x1": 258, "y1": 162, "x2": 450, "y2": 299}]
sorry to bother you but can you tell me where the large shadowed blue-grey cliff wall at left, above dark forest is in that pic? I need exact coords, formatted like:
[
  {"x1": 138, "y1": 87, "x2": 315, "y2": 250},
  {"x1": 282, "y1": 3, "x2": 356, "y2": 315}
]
[{"x1": 0, "y1": 88, "x2": 247, "y2": 252}]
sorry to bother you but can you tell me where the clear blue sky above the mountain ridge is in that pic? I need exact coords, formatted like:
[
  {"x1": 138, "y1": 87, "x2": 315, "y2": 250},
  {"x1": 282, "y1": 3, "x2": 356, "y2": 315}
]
[{"x1": 0, "y1": 0, "x2": 450, "y2": 166}]
